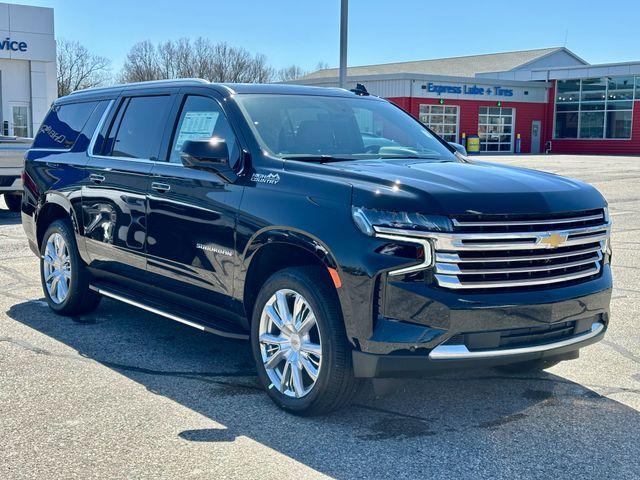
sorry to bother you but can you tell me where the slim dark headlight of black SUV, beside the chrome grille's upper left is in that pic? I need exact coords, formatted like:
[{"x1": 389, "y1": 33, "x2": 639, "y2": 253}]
[{"x1": 351, "y1": 207, "x2": 453, "y2": 236}]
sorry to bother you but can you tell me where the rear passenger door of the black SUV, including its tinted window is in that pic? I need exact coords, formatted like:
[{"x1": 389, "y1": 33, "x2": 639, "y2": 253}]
[{"x1": 82, "y1": 91, "x2": 176, "y2": 282}]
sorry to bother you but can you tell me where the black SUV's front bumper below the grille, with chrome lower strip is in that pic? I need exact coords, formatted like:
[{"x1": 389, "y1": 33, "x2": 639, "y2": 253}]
[{"x1": 353, "y1": 272, "x2": 611, "y2": 377}]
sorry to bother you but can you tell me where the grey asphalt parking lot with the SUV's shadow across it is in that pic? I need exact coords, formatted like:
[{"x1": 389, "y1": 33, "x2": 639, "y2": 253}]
[{"x1": 0, "y1": 156, "x2": 640, "y2": 479}]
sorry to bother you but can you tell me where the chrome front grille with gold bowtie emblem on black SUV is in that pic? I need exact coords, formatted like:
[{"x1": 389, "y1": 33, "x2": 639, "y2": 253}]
[{"x1": 433, "y1": 210, "x2": 610, "y2": 289}]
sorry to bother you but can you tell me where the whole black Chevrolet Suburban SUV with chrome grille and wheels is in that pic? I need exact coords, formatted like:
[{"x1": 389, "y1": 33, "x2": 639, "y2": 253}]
[{"x1": 22, "y1": 80, "x2": 611, "y2": 414}]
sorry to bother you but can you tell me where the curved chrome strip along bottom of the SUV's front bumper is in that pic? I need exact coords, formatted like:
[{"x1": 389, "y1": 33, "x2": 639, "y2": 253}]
[{"x1": 429, "y1": 322, "x2": 604, "y2": 360}]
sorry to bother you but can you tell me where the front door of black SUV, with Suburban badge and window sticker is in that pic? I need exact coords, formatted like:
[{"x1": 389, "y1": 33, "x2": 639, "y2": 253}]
[{"x1": 147, "y1": 95, "x2": 242, "y2": 307}]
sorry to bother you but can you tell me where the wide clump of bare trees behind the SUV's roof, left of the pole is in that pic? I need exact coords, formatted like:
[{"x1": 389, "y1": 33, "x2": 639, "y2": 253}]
[{"x1": 122, "y1": 37, "x2": 274, "y2": 83}]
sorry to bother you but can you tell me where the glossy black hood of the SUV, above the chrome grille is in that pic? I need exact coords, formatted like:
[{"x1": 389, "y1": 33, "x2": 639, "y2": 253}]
[{"x1": 325, "y1": 159, "x2": 606, "y2": 215}]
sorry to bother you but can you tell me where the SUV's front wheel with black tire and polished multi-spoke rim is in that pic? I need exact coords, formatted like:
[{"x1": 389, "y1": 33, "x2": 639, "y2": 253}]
[{"x1": 251, "y1": 267, "x2": 358, "y2": 416}]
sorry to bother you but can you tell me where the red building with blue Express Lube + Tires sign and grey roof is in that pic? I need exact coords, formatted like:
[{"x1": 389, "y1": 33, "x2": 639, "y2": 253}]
[{"x1": 295, "y1": 48, "x2": 640, "y2": 155}]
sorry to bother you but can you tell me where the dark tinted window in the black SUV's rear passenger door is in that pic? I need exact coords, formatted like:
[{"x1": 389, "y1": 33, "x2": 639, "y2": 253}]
[{"x1": 111, "y1": 95, "x2": 171, "y2": 160}]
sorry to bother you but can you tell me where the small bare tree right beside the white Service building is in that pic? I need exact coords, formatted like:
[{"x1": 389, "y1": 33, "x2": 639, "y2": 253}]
[{"x1": 57, "y1": 40, "x2": 111, "y2": 97}]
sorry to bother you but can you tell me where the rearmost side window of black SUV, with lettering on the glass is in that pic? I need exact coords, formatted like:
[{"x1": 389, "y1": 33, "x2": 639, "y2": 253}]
[{"x1": 33, "y1": 102, "x2": 98, "y2": 150}]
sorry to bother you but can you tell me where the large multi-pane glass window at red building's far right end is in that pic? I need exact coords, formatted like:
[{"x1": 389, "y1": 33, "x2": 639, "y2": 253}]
[{"x1": 554, "y1": 77, "x2": 634, "y2": 139}]
